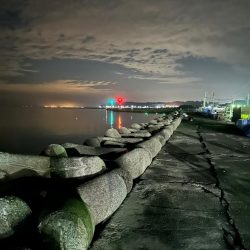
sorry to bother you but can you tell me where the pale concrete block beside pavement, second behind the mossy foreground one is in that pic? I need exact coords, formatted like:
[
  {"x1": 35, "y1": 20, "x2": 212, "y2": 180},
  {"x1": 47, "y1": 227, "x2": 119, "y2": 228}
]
[{"x1": 115, "y1": 148, "x2": 152, "y2": 179}]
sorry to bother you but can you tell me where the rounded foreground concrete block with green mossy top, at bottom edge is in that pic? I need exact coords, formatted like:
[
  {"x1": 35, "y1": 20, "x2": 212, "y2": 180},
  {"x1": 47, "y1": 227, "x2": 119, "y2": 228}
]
[{"x1": 38, "y1": 198, "x2": 95, "y2": 250}]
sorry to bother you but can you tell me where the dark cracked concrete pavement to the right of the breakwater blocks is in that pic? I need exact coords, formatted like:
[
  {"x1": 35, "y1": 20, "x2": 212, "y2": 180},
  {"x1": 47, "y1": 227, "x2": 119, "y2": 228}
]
[{"x1": 90, "y1": 120, "x2": 250, "y2": 250}]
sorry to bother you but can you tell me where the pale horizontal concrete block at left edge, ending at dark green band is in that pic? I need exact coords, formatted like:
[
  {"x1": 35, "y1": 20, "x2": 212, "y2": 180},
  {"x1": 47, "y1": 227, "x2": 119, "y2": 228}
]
[{"x1": 0, "y1": 152, "x2": 50, "y2": 180}]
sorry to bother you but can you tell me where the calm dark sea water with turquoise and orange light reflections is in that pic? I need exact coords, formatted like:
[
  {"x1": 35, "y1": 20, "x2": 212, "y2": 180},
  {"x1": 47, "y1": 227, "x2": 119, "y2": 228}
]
[{"x1": 0, "y1": 108, "x2": 156, "y2": 154}]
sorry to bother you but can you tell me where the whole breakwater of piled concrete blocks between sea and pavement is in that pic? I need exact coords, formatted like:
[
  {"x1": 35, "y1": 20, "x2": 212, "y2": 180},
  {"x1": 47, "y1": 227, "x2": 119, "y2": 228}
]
[{"x1": 0, "y1": 111, "x2": 181, "y2": 250}]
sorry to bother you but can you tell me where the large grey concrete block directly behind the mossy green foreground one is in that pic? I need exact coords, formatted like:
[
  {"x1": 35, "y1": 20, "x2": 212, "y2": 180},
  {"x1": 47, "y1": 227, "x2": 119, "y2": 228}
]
[{"x1": 77, "y1": 169, "x2": 133, "y2": 225}]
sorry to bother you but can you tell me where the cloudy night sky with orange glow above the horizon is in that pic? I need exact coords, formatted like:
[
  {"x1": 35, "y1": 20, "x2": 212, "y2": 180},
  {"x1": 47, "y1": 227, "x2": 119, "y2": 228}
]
[{"x1": 0, "y1": 0, "x2": 250, "y2": 105}]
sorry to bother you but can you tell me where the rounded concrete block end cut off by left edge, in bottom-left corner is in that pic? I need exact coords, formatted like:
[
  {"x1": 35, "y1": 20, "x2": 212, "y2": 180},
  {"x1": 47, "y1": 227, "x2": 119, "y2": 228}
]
[{"x1": 0, "y1": 196, "x2": 32, "y2": 239}]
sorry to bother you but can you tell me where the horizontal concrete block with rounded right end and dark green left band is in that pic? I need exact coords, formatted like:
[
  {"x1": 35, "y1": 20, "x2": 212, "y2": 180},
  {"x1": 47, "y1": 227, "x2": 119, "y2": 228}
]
[{"x1": 50, "y1": 156, "x2": 106, "y2": 178}]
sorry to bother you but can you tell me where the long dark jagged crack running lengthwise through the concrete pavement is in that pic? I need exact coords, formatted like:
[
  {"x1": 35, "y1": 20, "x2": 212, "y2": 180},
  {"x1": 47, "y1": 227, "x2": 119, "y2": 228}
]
[{"x1": 197, "y1": 126, "x2": 246, "y2": 250}]
